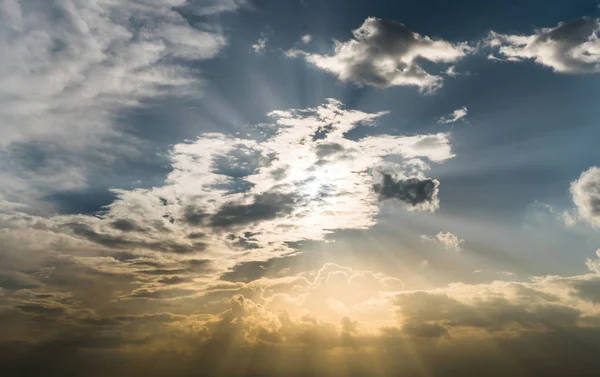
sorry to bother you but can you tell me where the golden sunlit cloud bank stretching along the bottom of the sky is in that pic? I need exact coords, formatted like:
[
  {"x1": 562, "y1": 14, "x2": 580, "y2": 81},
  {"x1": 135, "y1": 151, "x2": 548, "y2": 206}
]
[{"x1": 0, "y1": 264, "x2": 600, "y2": 377}]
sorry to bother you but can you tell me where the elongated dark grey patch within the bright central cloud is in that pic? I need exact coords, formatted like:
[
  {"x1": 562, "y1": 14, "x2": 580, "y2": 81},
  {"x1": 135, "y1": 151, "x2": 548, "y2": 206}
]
[{"x1": 210, "y1": 192, "x2": 297, "y2": 229}]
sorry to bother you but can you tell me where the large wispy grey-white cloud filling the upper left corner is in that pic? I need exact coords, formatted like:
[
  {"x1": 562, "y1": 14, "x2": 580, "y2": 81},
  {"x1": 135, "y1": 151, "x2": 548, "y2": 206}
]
[{"x1": 0, "y1": 0, "x2": 242, "y2": 203}]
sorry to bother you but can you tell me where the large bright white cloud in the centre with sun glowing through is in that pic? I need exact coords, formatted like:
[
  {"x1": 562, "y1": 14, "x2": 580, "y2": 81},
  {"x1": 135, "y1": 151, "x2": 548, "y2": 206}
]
[{"x1": 0, "y1": 99, "x2": 453, "y2": 284}]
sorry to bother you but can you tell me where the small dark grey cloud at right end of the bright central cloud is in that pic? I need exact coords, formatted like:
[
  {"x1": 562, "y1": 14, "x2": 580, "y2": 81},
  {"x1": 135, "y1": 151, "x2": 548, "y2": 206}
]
[{"x1": 373, "y1": 173, "x2": 439, "y2": 206}]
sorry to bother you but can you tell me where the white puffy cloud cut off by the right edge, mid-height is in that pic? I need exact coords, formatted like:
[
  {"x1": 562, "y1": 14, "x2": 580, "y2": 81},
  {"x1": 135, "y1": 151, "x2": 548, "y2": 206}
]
[{"x1": 571, "y1": 166, "x2": 600, "y2": 227}]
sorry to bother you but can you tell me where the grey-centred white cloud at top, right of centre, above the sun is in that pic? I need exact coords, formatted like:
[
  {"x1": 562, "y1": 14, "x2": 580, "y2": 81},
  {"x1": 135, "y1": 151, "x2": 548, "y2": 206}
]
[{"x1": 287, "y1": 17, "x2": 472, "y2": 91}]
